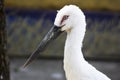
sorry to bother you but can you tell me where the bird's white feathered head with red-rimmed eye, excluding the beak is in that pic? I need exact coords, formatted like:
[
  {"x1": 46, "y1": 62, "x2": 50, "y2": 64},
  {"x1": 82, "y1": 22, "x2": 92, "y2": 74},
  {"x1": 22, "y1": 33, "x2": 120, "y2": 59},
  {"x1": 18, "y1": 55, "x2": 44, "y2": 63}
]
[{"x1": 54, "y1": 5, "x2": 85, "y2": 32}]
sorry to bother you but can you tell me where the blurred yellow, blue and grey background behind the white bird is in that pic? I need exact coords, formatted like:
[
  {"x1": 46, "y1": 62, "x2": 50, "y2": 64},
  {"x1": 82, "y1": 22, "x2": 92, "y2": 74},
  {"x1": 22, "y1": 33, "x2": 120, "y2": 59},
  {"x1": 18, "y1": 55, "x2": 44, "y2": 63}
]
[{"x1": 4, "y1": 0, "x2": 120, "y2": 80}]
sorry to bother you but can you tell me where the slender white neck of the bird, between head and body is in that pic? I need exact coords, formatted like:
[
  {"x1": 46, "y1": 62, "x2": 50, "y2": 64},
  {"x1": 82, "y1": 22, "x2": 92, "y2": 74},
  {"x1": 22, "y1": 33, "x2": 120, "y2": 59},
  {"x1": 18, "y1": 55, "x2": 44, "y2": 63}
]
[{"x1": 64, "y1": 24, "x2": 85, "y2": 62}]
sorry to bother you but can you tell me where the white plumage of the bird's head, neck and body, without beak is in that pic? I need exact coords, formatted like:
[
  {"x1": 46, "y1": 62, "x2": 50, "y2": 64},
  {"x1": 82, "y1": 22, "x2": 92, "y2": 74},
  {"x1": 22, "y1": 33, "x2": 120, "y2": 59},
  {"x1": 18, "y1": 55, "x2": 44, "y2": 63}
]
[{"x1": 54, "y1": 5, "x2": 110, "y2": 80}]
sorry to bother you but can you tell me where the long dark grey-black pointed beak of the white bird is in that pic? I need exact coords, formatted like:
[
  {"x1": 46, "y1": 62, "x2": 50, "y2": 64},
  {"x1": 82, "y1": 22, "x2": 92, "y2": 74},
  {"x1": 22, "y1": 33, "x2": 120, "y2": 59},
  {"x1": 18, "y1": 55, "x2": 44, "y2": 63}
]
[{"x1": 23, "y1": 26, "x2": 62, "y2": 68}]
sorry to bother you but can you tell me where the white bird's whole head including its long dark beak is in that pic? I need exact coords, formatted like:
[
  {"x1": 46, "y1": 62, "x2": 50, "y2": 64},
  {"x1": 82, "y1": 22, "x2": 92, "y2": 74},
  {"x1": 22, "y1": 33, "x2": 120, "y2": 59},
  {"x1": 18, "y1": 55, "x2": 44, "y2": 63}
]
[{"x1": 23, "y1": 5, "x2": 85, "y2": 67}]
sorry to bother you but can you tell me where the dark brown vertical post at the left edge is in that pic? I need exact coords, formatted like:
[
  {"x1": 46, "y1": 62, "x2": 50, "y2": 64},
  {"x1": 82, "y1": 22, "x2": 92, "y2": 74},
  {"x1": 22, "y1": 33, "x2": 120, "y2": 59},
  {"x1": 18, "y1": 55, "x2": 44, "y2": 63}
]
[{"x1": 0, "y1": 0, "x2": 10, "y2": 80}]
